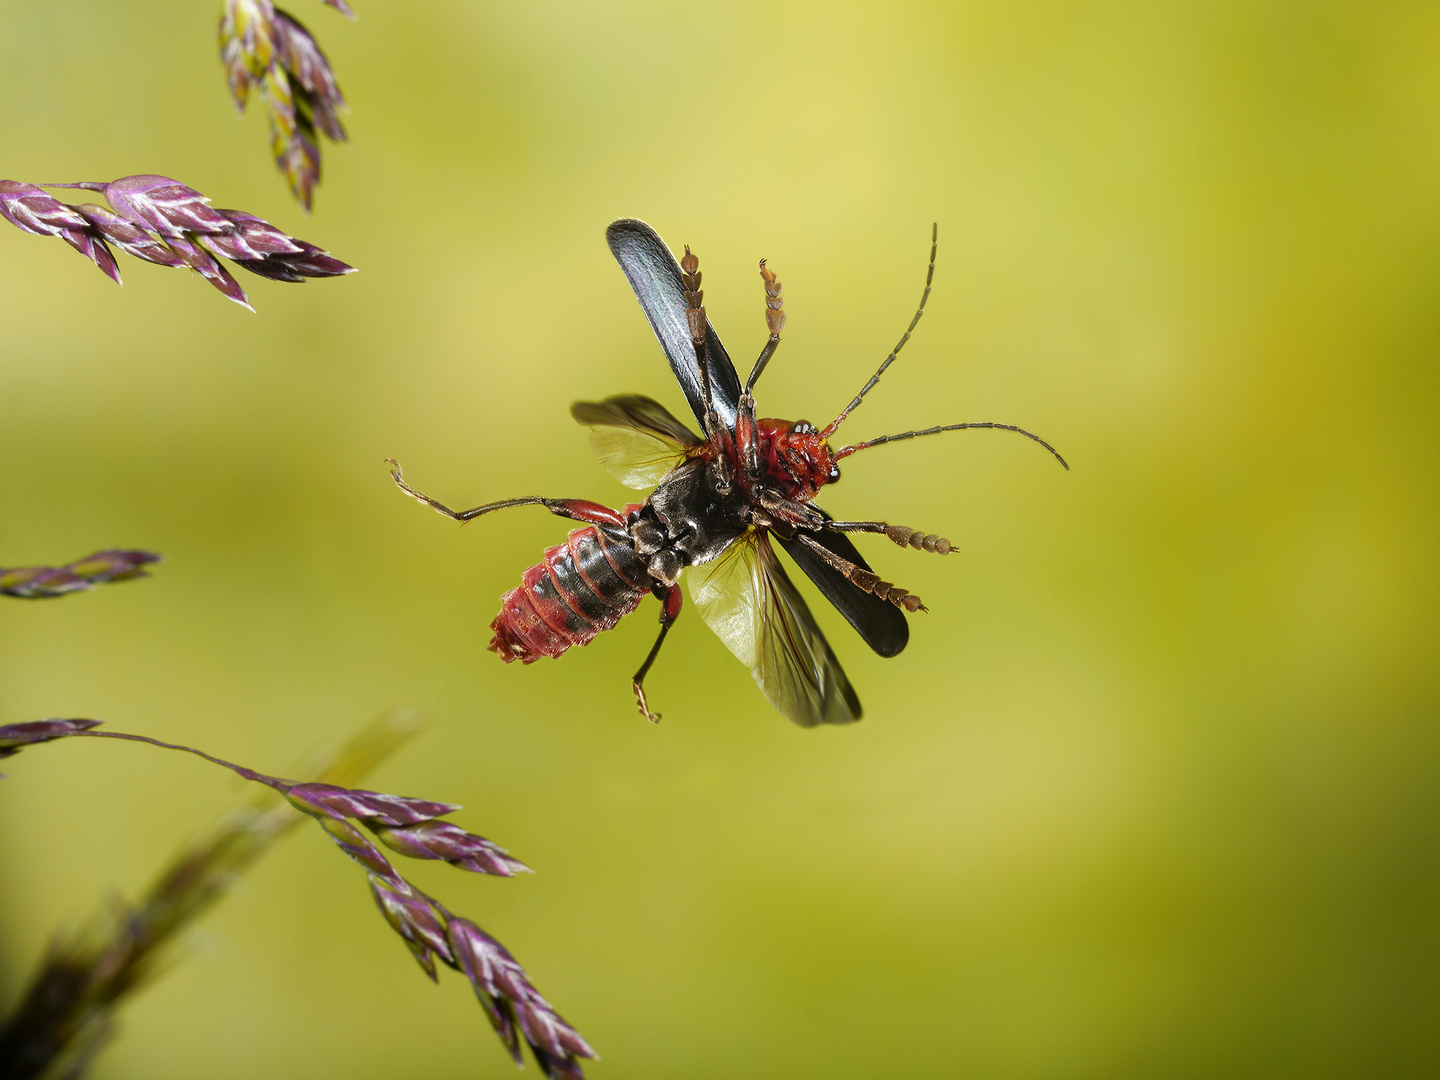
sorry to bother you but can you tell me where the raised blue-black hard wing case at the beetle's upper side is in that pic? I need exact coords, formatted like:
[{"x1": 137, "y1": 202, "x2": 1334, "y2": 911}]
[{"x1": 605, "y1": 217, "x2": 740, "y2": 431}]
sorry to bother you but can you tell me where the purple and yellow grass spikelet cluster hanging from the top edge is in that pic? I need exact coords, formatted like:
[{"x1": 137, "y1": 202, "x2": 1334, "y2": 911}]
[{"x1": 220, "y1": 0, "x2": 354, "y2": 210}]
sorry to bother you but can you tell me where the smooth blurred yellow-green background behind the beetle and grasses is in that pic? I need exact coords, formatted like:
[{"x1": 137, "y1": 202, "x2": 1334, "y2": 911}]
[{"x1": 0, "y1": 0, "x2": 1440, "y2": 1080}]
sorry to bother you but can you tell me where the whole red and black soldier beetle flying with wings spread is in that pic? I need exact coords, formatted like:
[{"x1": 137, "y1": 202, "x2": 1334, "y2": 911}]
[{"x1": 390, "y1": 220, "x2": 1070, "y2": 727}]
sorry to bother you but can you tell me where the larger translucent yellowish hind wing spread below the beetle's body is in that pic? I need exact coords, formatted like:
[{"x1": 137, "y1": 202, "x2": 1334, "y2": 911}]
[{"x1": 688, "y1": 533, "x2": 860, "y2": 727}]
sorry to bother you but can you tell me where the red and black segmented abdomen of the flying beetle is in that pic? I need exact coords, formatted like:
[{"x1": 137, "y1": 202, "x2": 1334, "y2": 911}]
[{"x1": 490, "y1": 526, "x2": 649, "y2": 664}]
